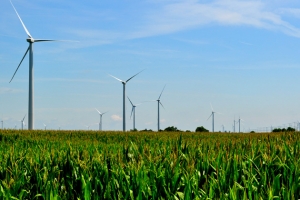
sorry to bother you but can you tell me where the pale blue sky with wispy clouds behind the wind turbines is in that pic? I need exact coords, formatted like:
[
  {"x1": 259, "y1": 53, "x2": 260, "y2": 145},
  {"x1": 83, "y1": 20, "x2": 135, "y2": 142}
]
[{"x1": 0, "y1": 0, "x2": 300, "y2": 131}]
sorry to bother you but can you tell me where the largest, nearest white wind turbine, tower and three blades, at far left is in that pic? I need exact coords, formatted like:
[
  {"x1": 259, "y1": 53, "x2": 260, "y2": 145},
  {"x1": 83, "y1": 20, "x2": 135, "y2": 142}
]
[{"x1": 9, "y1": 1, "x2": 60, "y2": 130}]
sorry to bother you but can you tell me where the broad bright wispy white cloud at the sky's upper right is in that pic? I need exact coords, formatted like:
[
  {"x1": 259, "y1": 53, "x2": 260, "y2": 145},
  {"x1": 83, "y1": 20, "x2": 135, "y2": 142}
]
[{"x1": 131, "y1": 0, "x2": 300, "y2": 38}]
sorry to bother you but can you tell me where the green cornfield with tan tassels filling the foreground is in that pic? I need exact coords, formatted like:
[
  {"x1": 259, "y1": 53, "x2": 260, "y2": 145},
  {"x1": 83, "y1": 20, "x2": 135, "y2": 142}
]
[{"x1": 0, "y1": 130, "x2": 300, "y2": 199}]
